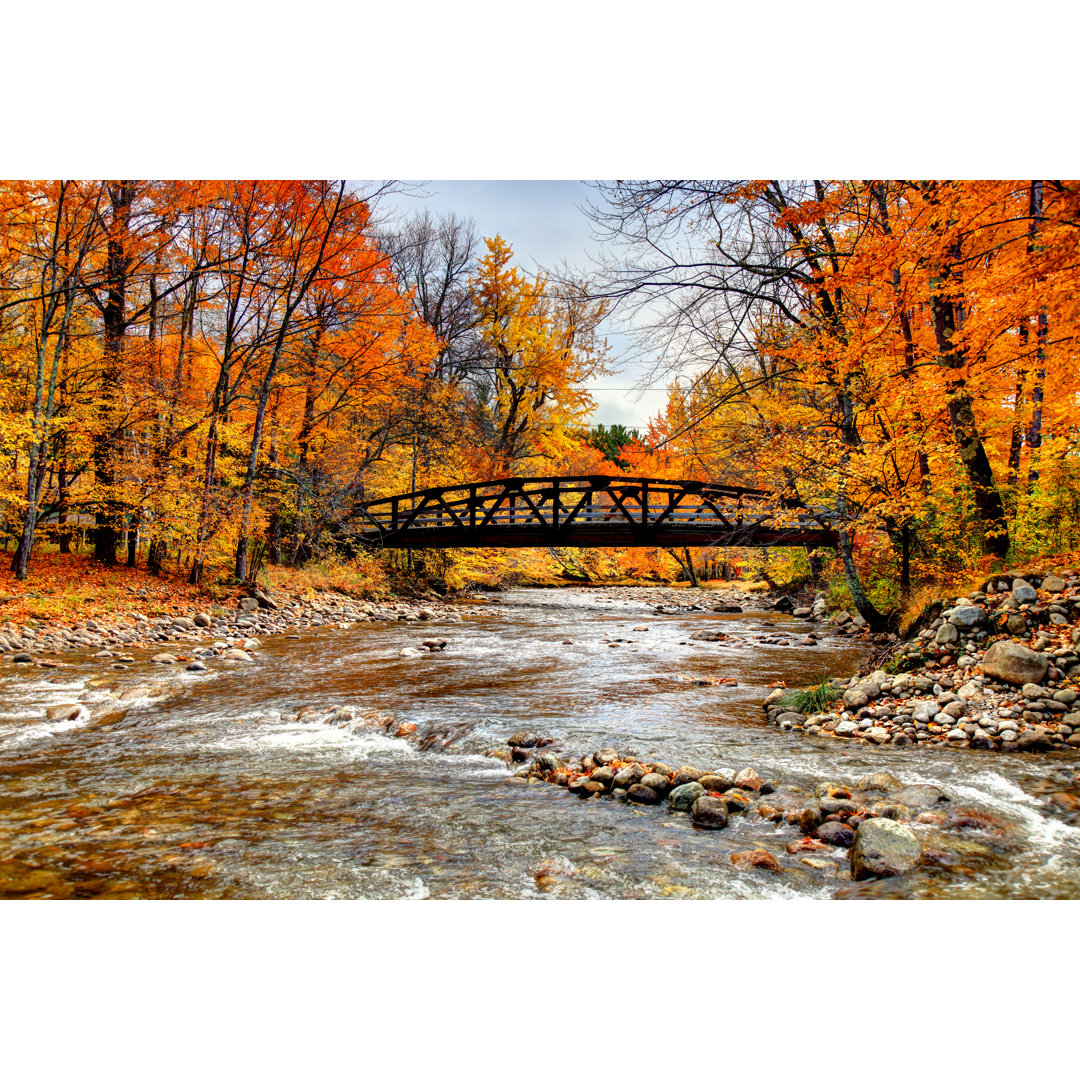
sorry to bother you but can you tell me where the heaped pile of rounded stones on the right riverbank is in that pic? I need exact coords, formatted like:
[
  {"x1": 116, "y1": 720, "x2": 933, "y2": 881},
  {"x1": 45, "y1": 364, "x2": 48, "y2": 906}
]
[{"x1": 764, "y1": 569, "x2": 1080, "y2": 752}]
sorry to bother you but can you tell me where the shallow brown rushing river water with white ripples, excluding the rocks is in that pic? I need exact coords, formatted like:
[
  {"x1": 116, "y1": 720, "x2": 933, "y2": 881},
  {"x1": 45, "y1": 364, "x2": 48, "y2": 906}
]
[{"x1": 0, "y1": 590, "x2": 1080, "y2": 899}]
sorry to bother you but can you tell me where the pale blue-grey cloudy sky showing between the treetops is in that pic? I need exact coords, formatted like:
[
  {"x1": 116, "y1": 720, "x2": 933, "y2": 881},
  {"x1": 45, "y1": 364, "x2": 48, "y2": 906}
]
[{"x1": 381, "y1": 180, "x2": 665, "y2": 429}]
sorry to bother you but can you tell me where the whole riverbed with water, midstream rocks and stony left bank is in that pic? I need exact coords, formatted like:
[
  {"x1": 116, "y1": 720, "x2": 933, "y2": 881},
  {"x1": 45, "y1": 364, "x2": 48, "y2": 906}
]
[{"x1": 0, "y1": 588, "x2": 1080, "y2": 897}]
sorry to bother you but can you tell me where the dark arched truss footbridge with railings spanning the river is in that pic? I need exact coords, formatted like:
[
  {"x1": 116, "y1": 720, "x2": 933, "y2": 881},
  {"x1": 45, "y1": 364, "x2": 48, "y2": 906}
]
[{"x1": 361, "y1": 476, "x2": 836, "y2": 549}]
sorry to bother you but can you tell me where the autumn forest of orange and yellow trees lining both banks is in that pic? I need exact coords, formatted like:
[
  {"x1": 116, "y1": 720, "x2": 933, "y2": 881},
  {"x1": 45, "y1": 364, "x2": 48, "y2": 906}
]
[{"x1": 0, "y1": 180, "x2": 1080, "y2": 627}]
